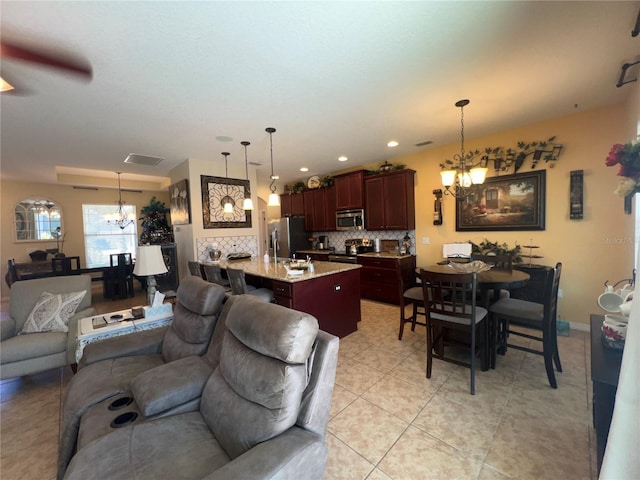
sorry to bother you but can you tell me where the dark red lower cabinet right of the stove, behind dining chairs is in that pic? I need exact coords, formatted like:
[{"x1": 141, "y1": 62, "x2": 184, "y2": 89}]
[{"x1": 358, "y1": 255, "x2": 416, "y2": 305}]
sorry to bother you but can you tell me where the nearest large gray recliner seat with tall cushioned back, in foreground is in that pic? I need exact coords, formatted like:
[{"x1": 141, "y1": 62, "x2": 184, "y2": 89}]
[{"x1": 64, "y1": 295, "x2": 339, "y2": 480}]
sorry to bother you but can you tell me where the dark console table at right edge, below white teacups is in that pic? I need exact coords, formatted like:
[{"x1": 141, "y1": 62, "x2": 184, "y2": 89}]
[{"x1": 591, "y1": 313, "x2": 622, "y2": 472}]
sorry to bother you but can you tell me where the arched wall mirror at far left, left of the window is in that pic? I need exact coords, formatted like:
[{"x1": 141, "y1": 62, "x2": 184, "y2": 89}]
[{"x1": 13, "y1": 198, "x2": 63, "y2": 242}]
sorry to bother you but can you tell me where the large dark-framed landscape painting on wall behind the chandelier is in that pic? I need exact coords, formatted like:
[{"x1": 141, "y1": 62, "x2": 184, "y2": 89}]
[{"x1": 456, "y1": 170, "x2": 547, "y2": 232}]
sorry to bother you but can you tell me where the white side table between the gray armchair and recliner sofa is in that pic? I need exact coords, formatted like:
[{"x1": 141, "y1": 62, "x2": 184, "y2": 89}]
[{"x1": 76, "y1": 309, "x2": 173, "y2": 363}]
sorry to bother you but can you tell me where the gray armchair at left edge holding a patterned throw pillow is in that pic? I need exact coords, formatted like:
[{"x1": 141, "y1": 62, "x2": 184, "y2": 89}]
[{"x1": 0, "y1": 275, "x2": 96, "y2": 380}]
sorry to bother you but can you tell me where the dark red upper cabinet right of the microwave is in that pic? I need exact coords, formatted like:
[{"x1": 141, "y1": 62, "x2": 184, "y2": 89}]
[{"x1": 364, "y1": 169, "x2": 416, "y2": 230}]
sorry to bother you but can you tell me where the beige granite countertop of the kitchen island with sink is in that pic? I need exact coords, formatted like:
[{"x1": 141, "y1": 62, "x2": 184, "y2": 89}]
[{"x1": 202, "y1": 258, "x2": 362, "y2": 283}]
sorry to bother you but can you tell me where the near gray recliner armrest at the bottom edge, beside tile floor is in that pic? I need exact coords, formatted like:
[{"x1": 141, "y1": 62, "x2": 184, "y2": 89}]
[{"x1": 202, "y1": 427, "x2": 327, "y2": 480}]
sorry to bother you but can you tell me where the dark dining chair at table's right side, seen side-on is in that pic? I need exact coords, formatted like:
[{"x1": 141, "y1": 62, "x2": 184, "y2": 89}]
[{"x1": 489, "y1": 262, "x2": 562, "y2": 388}]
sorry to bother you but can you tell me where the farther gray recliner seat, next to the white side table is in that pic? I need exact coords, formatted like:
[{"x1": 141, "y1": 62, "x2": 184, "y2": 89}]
[{"x1": 58, "y1": 276, "x2": 225, "y2": 477}]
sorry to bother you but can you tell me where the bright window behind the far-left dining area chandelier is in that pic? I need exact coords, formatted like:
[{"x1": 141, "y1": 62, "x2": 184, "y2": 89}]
[{"x1": 82, "y1": 205, "x2": 138, "y2": 268}]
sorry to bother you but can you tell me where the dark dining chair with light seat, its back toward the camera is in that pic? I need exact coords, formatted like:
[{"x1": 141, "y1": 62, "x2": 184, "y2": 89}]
[{"x1": 420, "y1": 269, "x2": 487, "y2": 395}]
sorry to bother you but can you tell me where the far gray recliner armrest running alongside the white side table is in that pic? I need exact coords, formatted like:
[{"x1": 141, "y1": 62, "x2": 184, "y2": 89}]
[{"x1": 78, "y1": 327, "x2": 169, "y2": 368}]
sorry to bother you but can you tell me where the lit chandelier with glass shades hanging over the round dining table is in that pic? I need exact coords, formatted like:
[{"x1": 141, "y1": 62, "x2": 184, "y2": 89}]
[{"x1": 440, "y1": 99, "x2": 487, "y2": 198}]
